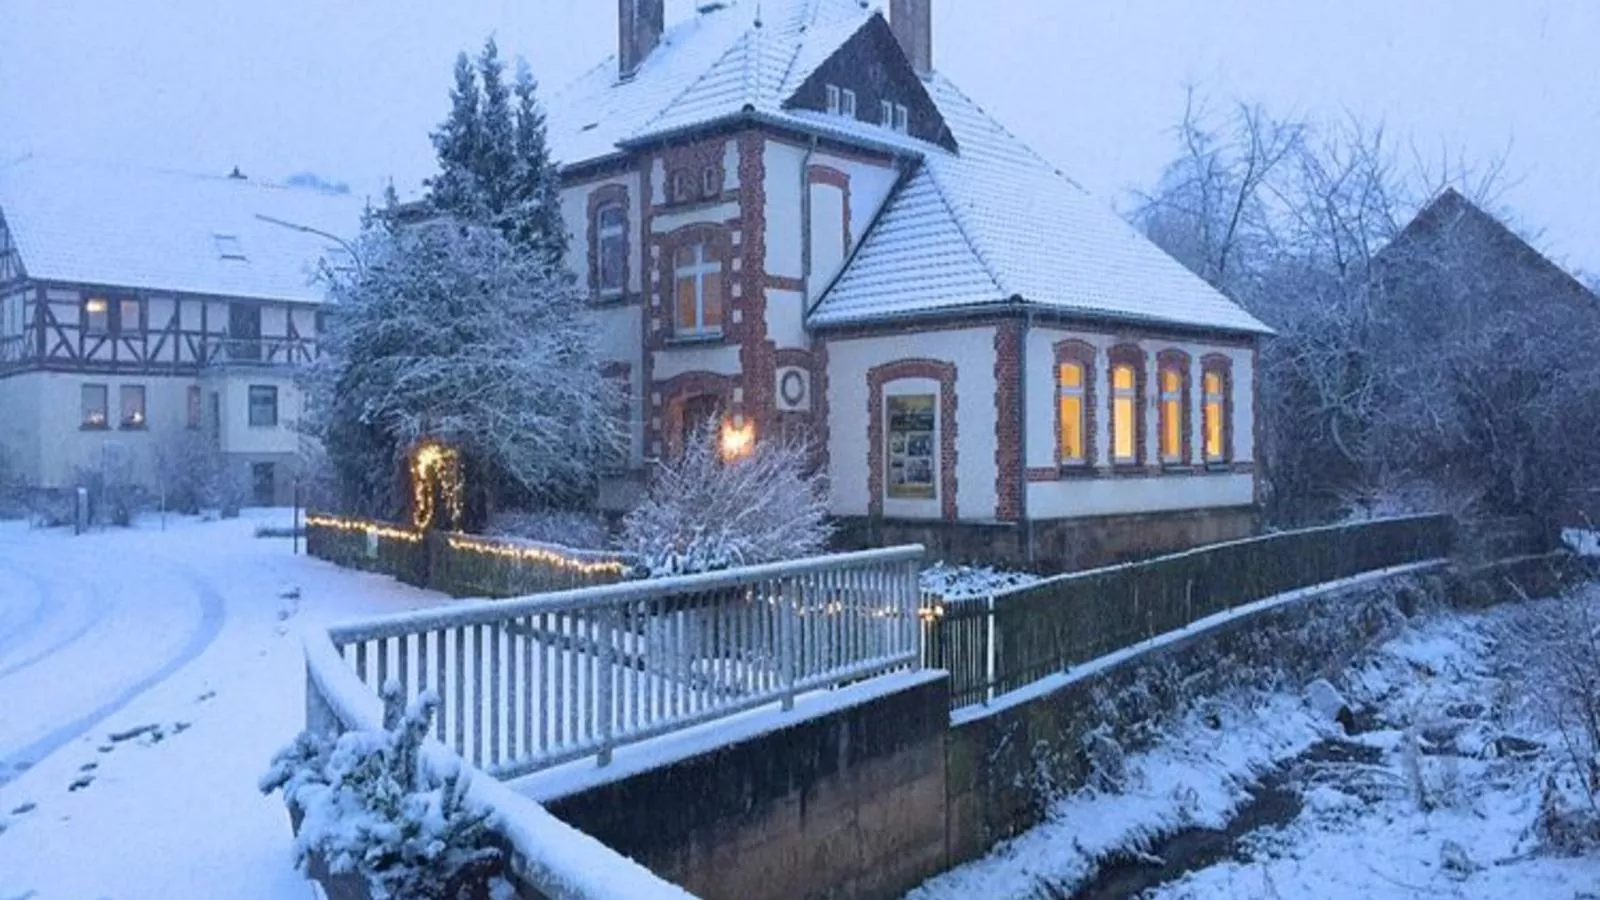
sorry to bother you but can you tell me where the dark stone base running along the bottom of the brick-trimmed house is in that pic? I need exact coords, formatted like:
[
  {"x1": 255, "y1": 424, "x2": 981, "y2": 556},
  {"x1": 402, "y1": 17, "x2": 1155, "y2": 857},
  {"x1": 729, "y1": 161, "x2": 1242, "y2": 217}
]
[{"x1": 835, "y1": 506, "x2": 1259, "y2": 575}]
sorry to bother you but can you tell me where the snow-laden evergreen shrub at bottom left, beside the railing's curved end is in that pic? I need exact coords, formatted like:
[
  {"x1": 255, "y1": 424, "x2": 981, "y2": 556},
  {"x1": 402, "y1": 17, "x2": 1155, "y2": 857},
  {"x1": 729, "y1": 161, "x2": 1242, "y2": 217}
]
[{"x1": 259, "y1": 682, "x2": 502, "y2": 900}]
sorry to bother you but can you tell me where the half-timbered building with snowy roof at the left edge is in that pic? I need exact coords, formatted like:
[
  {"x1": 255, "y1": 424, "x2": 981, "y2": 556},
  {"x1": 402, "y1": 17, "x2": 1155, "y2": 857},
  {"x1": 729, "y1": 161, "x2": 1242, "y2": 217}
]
[{"x1": 0, "y1": 159, "x2": 362, "y2": 504}]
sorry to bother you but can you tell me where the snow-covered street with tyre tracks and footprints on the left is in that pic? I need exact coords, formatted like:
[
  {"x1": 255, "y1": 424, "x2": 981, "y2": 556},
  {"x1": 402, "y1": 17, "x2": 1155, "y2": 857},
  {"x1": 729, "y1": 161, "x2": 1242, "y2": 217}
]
[{"x1": 0, "y1": 511, "x2": 448, "y2": 900}]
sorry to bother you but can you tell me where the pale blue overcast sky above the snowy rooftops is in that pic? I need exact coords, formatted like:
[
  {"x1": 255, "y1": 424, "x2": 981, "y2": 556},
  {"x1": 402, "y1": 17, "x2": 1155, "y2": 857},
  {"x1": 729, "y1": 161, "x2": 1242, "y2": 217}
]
[{"x1": 0, "y1": 0, "x2": 1600, "y2": 272}]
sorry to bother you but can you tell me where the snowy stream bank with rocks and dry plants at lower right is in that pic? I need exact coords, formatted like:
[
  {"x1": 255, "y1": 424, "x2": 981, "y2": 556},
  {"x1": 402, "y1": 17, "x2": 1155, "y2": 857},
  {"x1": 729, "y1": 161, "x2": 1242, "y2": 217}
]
[{"x1": 909, "y1": 599, "x2": 1600, "y2": 900}]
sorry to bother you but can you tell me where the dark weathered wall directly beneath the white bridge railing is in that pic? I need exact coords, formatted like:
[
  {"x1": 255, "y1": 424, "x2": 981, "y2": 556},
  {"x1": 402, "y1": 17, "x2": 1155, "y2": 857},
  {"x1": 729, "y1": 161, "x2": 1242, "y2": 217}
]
[{"x1": 546, "y1": 676, "x2": 949, "y2": 900}]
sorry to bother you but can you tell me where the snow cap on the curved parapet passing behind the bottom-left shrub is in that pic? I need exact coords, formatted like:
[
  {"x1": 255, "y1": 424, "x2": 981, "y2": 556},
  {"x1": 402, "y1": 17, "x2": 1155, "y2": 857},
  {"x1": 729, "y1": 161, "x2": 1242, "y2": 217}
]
[{"x1": 306, "y1": 633, "x2": 693, "y2": 900}]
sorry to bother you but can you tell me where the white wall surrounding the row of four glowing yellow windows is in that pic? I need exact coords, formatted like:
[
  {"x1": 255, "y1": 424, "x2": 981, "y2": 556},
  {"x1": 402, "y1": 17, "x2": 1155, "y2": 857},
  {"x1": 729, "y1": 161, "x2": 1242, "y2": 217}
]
[{"x1": 1026, "y1": 325, "x2": 1254, "y2": 519}]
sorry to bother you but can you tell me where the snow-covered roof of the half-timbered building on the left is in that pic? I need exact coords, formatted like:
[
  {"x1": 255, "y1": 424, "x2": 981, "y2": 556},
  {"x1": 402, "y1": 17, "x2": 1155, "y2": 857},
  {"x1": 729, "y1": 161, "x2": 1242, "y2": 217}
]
[{"x1": 0, "y1": 157, "x2": 365, "y2": 303}]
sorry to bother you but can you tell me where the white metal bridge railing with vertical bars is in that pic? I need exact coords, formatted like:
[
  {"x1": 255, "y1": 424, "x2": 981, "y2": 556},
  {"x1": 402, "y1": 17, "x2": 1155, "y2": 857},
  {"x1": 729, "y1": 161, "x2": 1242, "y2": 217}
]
[{"x1": 328, "y1": 546, "x2": 923, "y2": 778}]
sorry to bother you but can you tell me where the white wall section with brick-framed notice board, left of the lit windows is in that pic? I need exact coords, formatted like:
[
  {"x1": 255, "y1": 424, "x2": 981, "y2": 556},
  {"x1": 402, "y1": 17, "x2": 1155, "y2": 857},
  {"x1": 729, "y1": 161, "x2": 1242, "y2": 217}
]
[{"x1": 827, "y1": 327, "x2": 997, "y2": 520}]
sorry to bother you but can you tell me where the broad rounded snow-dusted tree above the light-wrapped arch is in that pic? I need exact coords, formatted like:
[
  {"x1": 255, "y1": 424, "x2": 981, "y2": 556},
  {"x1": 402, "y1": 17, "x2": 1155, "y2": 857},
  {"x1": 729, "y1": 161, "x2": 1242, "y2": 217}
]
[{"x1": 310, "y1": 216, "x2": 618, "y2": 516}]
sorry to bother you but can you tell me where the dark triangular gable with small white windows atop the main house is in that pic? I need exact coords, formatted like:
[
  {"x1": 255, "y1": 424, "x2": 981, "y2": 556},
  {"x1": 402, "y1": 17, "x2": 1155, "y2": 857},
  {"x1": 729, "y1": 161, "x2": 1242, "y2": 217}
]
[{"x1": 782, "y1": 14, "x2": 957, "y2": 152}]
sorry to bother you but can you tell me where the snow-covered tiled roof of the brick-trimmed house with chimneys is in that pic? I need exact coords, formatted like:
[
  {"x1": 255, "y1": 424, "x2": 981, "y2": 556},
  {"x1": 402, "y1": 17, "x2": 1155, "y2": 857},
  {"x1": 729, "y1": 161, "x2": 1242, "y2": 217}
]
[{"x1": 549, "y1": 0, "x2": 1269, "y2": 333}]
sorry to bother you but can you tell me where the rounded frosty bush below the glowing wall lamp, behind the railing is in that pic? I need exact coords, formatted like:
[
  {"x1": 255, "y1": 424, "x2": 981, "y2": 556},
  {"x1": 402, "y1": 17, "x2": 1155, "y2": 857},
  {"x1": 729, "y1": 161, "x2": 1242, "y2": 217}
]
[{"x1": 622, "y1": 428, "x2": 830, "y2": 577}]
